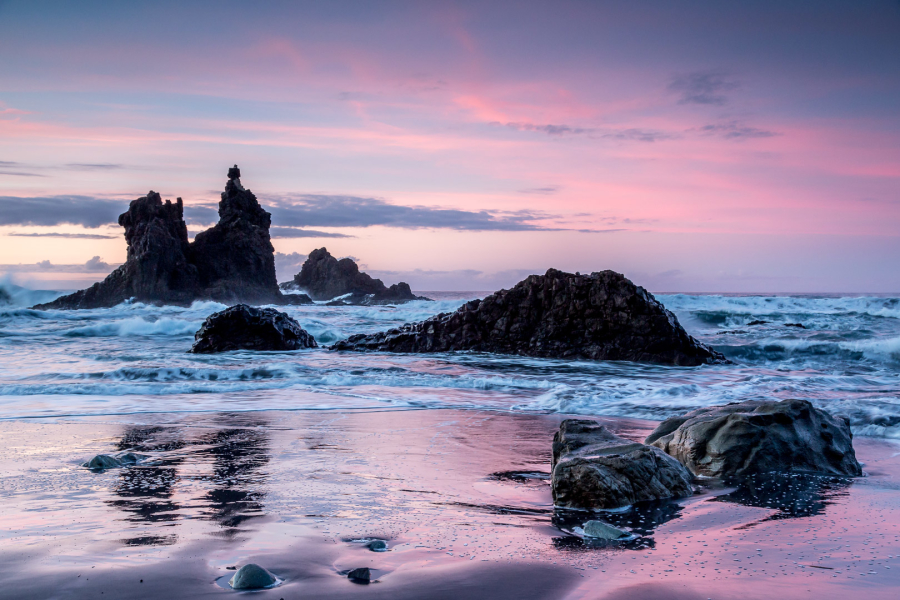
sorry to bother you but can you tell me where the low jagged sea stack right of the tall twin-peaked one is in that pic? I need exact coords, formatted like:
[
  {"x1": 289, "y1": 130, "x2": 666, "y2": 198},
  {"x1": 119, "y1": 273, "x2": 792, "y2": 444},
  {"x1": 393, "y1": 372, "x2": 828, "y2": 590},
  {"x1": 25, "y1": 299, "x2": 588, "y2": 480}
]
[{"x1": 281, "y1": 248, "x2": 429, "y2": 305}]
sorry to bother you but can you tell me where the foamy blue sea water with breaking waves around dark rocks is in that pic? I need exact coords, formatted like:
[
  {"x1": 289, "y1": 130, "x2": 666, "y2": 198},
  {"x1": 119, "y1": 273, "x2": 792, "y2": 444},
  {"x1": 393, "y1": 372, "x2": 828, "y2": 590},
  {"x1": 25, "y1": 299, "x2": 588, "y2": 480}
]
[{"x1": 0, "y1": 289, "x2": 900, "y2": 438}]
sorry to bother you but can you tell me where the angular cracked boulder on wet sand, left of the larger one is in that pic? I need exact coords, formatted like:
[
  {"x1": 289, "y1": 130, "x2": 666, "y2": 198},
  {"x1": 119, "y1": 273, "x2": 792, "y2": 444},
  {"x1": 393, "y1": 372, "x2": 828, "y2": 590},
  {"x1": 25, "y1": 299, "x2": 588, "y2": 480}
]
[{"x1": 550, "y1": 419, "x2": 693, "y2": 509}]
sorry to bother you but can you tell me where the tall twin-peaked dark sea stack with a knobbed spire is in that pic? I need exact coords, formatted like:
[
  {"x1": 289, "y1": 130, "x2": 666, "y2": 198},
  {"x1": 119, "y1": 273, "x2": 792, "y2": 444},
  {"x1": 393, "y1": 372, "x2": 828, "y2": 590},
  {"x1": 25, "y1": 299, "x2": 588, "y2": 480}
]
[{"x1": 35, "y1": 165, "x2": 311, "y2": 309}]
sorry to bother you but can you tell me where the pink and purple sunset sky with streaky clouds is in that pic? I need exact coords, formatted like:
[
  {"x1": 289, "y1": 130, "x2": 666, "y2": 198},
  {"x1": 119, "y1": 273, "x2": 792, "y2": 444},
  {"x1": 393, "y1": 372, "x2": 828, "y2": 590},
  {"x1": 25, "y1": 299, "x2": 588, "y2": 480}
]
[{"x1": 0, "y1": 0, "x2": 900, "y2": 293}]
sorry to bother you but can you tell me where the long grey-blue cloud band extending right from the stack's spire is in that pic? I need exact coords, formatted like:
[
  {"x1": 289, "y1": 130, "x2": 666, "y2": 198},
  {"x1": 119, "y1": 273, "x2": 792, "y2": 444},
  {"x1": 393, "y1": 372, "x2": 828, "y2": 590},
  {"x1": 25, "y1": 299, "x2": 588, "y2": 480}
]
[{"x1": 266, "y1": 194, "x2": 560, "y2": 231}]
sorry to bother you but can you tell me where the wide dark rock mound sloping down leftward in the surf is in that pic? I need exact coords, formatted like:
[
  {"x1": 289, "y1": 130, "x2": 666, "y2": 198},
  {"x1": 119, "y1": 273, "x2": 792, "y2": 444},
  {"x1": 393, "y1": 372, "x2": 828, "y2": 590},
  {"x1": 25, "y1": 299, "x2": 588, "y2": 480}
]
[{"x1": 332, "y1": 269, "x2": 725, "y2": 366}]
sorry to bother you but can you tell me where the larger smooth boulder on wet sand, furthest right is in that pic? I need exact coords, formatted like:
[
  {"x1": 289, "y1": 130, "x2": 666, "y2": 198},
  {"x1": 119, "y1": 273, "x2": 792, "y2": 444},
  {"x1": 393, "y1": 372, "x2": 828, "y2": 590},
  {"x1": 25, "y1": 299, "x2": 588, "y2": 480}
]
[{"x1": 646, "y1": 400, "x2": 862, "y2": 479}]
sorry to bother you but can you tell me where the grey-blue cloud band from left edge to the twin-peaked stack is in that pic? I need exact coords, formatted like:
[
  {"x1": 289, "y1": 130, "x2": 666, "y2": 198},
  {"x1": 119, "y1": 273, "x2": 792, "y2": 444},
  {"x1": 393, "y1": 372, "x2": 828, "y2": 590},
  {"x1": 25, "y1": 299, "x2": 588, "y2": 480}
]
[{"x1": 0, "y1": 196, "x2": 128, "y2": 228}]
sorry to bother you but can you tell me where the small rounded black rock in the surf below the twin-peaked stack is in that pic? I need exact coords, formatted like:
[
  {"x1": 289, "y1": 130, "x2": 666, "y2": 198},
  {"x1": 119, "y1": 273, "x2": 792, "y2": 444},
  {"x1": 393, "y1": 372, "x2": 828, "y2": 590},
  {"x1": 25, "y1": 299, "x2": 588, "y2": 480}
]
[{"x1": 190, "y1": 304, "x2": 318, "y2": 354}]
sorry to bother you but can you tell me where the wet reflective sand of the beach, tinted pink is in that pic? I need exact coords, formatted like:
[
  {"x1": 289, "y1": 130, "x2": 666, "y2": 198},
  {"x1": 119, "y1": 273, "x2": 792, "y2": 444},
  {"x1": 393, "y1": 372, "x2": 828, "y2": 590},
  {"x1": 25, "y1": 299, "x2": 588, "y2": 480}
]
[{"x1": 0, "y1": 410, "x2": 900, "y2": 600}]
